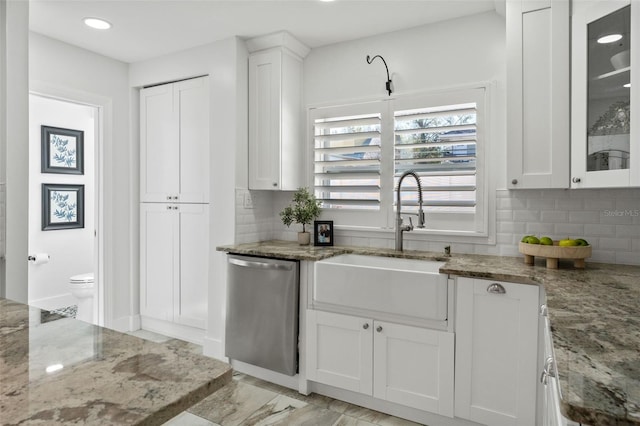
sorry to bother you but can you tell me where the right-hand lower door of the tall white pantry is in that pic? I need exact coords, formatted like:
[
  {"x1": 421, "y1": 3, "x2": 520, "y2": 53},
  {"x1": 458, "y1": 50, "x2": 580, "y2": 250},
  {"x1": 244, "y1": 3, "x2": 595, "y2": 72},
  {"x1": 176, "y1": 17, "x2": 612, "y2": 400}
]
[{"x1": 174, "y1": 204, "x2": 209, "y2": 329}]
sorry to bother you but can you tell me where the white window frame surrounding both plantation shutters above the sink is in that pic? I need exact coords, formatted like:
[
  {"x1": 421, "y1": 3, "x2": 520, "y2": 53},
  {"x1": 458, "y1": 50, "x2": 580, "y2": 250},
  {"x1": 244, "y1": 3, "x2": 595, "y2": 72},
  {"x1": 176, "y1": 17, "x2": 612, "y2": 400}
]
[{"x1": 307, "y1": 83, "x2": 495, "y2": 243}]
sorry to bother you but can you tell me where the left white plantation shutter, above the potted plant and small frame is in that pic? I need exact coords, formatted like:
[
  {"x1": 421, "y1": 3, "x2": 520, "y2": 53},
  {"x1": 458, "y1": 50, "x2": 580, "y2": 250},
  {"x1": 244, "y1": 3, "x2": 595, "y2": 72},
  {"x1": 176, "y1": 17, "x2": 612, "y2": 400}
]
[{"x1": 313, "y1": 112, "x2": 381, "y2": 211}]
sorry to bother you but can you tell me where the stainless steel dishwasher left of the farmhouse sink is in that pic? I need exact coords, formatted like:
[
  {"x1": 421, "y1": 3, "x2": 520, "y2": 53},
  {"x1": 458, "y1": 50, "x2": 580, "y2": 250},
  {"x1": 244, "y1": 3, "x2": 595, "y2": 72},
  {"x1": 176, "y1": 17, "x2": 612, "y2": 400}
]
[{"x1": 225, "y1": 255, "x2": 299, "y2": 376}]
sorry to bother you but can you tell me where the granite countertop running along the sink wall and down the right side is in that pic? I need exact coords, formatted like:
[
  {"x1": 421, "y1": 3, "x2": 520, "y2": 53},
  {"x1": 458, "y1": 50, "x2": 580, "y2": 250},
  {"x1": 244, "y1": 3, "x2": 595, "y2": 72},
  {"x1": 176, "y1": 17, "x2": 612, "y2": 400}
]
[{"x1": 218, "y1": 241, "x2": 640, "y2": 426}]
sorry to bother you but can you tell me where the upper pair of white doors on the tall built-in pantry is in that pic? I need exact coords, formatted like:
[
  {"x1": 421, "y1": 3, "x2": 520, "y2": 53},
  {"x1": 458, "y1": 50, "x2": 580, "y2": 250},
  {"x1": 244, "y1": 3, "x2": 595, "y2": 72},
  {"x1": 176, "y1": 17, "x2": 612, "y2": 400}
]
[{"x1": 140, "y1": 77, "x2": 209, "y2": 203}]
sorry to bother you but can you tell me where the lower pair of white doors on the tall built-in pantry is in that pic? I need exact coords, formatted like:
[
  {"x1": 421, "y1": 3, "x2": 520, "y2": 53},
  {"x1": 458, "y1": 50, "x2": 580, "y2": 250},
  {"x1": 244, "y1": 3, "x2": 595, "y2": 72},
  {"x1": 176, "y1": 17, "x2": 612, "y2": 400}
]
[{"x1": 140, "y1": 203, "x2": 209, "y2": 329}]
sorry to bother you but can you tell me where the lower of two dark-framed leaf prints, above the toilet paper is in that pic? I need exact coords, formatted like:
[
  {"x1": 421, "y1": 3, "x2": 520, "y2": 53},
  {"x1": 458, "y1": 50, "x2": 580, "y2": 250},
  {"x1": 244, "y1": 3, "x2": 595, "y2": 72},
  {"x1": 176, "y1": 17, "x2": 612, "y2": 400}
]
[{"x1": 42, "y1": 183, "x2": 84, "y2": 231}]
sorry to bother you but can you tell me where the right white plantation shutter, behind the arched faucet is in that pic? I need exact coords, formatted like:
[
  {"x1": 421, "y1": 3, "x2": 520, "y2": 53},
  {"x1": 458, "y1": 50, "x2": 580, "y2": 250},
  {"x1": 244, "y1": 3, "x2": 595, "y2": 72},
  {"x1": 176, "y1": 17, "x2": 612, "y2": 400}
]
[{"x1": 394, "y1": 102, "x2": 477, "y2": 213}]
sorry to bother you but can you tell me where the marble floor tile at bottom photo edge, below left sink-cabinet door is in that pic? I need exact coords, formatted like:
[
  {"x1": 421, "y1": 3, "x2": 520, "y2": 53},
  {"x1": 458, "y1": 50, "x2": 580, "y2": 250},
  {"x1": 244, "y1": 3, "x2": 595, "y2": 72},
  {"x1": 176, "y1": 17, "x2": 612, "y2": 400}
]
[{"x1": 244, "y1": 395, "x2": 341, "y2": 426}]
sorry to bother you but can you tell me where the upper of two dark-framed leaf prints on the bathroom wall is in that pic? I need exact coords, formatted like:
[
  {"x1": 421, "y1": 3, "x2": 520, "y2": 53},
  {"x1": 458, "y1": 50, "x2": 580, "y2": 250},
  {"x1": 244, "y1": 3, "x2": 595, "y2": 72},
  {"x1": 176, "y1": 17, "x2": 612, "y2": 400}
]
[{"x1": 40, "y1": 126, "x2": 84, "y2": 175}]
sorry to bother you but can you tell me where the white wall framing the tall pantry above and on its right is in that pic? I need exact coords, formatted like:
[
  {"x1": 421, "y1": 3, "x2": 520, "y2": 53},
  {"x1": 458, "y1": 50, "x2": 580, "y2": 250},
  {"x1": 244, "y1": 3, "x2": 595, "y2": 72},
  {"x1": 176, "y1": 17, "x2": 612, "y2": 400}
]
[{"x1": 130, "y1": 37, "x2": 248, "y2": 358}]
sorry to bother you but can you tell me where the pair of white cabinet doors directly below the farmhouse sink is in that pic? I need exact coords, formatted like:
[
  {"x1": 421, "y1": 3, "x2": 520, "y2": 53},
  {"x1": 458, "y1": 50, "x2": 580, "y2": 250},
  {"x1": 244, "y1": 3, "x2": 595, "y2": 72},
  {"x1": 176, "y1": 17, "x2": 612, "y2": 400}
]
[{"x1": 307, "y1": 310, "x2": 454, "y2": 417}]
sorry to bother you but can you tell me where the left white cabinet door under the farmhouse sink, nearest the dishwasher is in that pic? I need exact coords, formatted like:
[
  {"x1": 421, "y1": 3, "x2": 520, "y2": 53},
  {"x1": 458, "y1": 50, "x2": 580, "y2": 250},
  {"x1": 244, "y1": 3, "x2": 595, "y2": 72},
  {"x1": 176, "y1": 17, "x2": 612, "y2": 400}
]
[{"x1": 307, "y1": 310, "x2": 373, "y2": 395}]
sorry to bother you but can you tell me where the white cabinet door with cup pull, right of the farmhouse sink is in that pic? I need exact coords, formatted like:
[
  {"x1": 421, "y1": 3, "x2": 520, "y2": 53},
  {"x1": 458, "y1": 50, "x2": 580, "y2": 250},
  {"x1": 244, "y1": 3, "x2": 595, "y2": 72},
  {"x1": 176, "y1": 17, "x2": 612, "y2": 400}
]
[{"x1": 455, "y1": 278, "x2": 539, "y2": 426}]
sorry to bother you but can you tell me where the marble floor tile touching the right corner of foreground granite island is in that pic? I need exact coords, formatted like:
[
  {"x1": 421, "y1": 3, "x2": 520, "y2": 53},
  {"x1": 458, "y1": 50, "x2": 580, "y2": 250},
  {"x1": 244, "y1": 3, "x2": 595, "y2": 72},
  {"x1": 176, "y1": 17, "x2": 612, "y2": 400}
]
[{"x1": 187, "y1": 380, "x2": 278, "y2": 426}]
